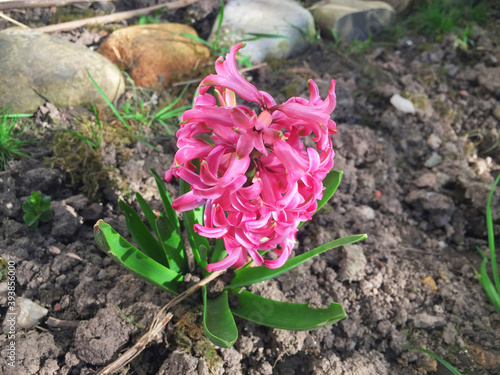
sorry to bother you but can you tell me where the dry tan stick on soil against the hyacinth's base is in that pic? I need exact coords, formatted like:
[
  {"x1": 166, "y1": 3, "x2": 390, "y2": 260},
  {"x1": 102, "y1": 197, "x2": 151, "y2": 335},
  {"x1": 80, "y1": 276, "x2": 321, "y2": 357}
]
[{"x1": 99, "y1": 270, "x2": 226, "y2": 375}]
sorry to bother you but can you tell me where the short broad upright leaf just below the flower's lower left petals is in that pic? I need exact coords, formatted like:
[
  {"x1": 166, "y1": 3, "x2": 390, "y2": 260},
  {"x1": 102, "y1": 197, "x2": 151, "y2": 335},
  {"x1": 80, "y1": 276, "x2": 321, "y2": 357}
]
[{"x1": 155, "y1": 214, "x2": 188, "y2": 273}]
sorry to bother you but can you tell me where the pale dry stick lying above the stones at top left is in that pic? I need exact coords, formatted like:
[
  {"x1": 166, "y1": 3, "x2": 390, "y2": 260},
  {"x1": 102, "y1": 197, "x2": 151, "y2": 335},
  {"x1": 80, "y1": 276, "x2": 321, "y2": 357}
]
[{"x1": 36, "y1": 0, "x2": 200, "y2": 33}]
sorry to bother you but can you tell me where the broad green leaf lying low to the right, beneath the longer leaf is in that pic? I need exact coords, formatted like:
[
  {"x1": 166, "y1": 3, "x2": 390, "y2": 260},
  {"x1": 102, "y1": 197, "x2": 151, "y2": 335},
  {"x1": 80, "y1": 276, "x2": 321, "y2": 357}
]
[{"x1": 231, "y1": 289, "x2": 346, "y2": 331}]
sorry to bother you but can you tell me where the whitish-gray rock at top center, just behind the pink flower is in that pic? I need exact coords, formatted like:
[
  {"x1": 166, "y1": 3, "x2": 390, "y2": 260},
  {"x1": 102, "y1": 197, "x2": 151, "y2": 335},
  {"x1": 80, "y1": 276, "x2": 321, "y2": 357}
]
[{"x1": 209, "y1": 0, "x2": 315, "y2": 63}]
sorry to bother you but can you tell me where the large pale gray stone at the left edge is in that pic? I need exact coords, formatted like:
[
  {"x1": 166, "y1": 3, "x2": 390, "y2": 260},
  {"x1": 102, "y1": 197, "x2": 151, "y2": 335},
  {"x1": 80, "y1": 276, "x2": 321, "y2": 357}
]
[{"x1": 0, "y1": 28, "x2": 125, "y2": 113}]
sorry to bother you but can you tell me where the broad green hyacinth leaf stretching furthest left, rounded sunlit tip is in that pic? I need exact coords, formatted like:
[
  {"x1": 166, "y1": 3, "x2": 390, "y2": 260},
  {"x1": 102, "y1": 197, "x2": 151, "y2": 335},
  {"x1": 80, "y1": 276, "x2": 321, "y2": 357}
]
[{"x1": 94, "y1": 220, "x2": 183, "y2": 294}]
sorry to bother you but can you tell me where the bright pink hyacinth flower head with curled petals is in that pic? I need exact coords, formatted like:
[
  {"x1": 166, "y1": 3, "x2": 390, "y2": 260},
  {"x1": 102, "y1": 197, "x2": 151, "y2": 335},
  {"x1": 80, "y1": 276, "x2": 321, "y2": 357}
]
[{"x1": 165, "y1": 43, "x2": 336, "y2": 271}]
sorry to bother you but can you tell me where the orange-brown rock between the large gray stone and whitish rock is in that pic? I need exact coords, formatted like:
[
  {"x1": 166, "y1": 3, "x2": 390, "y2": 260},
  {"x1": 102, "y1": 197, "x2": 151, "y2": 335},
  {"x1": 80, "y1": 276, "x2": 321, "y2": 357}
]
[{"x1": 98, "y1": 23, "x2": 210, "y2": 87}]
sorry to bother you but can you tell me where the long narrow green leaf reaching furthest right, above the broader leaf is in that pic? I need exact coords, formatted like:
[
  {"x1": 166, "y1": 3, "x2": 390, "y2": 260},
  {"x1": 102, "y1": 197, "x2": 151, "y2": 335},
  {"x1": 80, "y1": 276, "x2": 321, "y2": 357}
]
[{"x1": 226, "y1": 234, "x2": 368, "y2": 289}]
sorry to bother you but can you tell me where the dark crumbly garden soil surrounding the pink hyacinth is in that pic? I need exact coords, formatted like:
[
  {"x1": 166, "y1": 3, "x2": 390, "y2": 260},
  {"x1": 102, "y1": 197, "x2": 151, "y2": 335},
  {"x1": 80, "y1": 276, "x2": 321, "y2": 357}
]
[{"x1": 0, "y1": 1, "x2": 500, "y2": 375}]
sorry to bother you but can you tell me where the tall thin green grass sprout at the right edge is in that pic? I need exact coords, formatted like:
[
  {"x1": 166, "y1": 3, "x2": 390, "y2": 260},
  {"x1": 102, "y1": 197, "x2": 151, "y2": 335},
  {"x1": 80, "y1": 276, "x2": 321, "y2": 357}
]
[{"x1": 474, "y1": 175, "x2": 500, "y2": 313}]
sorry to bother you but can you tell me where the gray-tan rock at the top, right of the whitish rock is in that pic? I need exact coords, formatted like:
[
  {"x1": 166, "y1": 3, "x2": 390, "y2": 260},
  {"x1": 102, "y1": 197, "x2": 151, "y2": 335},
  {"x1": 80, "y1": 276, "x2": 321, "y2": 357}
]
[{"x1": 312, "y1": 0, "x2": 396, "y2": 41}]
